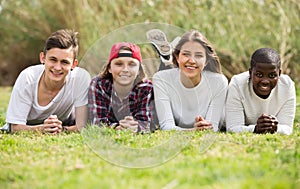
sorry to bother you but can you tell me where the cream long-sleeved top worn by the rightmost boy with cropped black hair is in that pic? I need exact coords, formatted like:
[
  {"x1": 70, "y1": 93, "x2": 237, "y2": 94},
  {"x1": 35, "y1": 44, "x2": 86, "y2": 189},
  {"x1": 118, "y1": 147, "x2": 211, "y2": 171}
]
[{"x1": 226, "y1": 72, "x2": 296, "y2": 134}]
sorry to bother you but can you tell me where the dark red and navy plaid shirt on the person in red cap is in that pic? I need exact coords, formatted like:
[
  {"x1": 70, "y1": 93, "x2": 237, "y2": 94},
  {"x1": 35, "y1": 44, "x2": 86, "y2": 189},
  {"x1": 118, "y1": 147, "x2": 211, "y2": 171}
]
[{"x1": 88, "y1": 76, "x2": 153, "y2": 132}]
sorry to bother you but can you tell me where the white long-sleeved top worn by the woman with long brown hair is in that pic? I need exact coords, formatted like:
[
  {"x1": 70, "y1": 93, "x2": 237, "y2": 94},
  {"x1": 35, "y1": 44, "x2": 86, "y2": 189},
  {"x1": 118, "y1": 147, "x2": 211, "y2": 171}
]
[{"x1": 153, "y1": 68, "x2": 228, "y2": 131}]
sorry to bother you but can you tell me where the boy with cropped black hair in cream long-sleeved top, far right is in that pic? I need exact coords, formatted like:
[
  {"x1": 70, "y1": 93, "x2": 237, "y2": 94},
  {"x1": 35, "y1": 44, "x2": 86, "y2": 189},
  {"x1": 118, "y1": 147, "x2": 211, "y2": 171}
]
[{"x1": 226, "y1": 48, "x2": 296, "y2": 135}]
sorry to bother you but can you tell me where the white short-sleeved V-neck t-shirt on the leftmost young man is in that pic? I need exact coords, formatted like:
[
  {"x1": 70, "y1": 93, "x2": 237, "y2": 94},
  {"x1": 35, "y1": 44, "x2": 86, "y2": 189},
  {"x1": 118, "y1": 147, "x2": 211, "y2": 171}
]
[{"x1": 6, "y1": 65, "x2": 91, "y2": 125}]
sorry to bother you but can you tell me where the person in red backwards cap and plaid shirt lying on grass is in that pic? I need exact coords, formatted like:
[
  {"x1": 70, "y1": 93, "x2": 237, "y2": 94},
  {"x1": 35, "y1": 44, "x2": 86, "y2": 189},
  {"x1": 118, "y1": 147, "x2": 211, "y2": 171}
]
[{"x1": 88, "y1": 42, "x2": 153, "y2": 133}]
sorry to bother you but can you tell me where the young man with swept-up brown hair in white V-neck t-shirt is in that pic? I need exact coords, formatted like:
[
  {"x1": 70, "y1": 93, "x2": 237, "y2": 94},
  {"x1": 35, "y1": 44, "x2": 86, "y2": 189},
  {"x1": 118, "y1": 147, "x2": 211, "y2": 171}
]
[{"x1": 3, "y1": 30, "x2": 90, "y2": 134}]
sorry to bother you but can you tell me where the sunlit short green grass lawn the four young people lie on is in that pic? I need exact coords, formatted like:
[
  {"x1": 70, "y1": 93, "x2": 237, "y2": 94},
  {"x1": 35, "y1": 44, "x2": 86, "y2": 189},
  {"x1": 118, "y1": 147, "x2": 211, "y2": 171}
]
[{"x1": 0, "y1": 88, "x2": 300, "y2": 189}]
